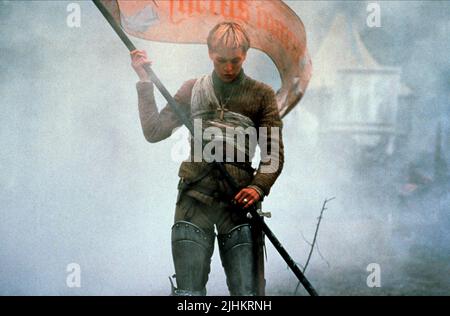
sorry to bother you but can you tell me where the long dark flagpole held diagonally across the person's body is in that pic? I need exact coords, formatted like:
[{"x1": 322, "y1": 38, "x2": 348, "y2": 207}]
[{"x1": 92, "y1": 0, "x2": 318, "y2": 296}]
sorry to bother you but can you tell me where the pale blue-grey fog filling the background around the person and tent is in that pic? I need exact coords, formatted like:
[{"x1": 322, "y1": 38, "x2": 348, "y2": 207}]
[{"x1": 0, "y1": 1, "x2": 450, "y2": 295}]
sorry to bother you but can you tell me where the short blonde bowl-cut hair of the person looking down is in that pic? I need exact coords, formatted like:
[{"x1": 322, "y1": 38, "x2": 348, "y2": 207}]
[{"x1": 207, "y1": 22, "x2": 250, "y2": 52}]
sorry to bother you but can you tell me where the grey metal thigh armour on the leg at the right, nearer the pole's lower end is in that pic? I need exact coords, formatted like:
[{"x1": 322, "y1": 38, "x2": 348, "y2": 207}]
[{"x1": 218, "y1": 224, "x2": 258, "y2": 296}]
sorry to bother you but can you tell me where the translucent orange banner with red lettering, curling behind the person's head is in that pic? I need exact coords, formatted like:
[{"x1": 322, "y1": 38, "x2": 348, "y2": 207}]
[{"x1": 104, "y1": 0, "x2": 312, "y2": 116}]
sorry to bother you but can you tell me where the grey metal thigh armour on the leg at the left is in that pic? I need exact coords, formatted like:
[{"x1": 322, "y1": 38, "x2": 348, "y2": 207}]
[{"x1": 172, "y1": 221, "x2": 215, "y2": 296}]
